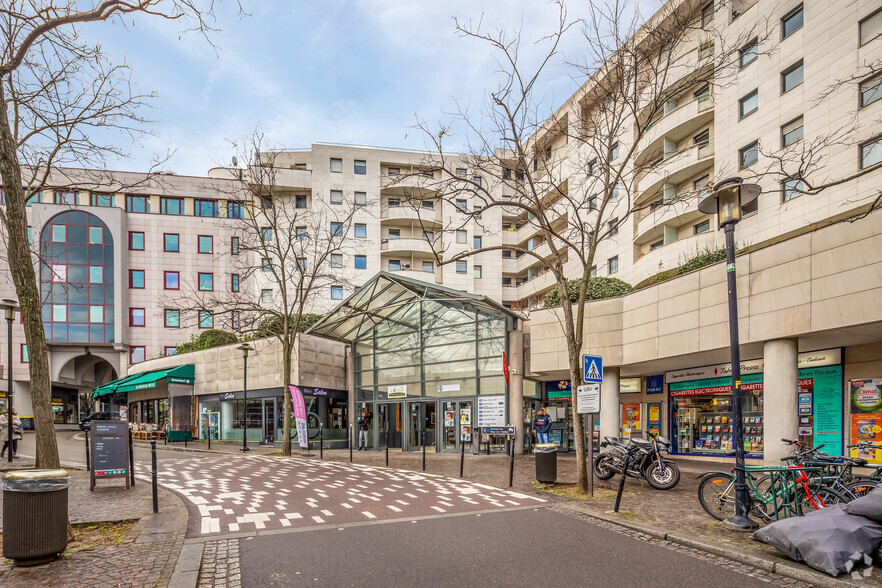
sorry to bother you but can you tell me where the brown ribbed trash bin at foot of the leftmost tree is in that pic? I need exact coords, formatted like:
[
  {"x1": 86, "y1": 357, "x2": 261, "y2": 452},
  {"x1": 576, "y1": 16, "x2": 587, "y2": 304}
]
[{"x1": 2, "y1": 470, "x2": 70, "y2": 566}]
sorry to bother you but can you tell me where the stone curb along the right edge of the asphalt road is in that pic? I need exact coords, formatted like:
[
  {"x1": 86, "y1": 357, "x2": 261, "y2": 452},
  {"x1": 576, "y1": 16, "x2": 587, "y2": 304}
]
[{"x1": 563, "y1": 503, "x2": 854, "y2": 588}]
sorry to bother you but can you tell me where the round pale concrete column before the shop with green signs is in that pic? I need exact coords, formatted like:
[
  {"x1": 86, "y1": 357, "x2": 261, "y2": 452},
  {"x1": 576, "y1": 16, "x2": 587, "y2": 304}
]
[{"x1": 763, "y1": 339, "x2": 799, "y2": 465}]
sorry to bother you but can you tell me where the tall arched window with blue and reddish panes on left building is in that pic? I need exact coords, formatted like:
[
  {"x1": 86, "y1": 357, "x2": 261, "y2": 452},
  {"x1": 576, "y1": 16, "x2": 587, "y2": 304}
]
[{"x1": 40, "y1": 210, "x2": 114, "y2": 343}]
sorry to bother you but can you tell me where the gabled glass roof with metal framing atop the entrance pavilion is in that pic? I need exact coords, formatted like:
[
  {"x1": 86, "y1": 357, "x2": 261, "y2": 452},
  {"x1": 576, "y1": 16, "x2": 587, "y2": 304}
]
[{"x1": 308, "y1": 272, "x2": 523, "y2": 347}]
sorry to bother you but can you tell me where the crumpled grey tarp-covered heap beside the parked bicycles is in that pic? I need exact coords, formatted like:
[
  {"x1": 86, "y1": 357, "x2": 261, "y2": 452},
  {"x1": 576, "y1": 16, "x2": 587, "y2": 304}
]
[{"x1": 750, "y1": 504, "x2": 882, "y2": 576}]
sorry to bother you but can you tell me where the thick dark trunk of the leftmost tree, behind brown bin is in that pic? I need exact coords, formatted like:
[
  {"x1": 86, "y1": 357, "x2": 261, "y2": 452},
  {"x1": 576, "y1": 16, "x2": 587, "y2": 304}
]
[{"x1": 0, "y1": 88, "x2": 60, "y2": 468}]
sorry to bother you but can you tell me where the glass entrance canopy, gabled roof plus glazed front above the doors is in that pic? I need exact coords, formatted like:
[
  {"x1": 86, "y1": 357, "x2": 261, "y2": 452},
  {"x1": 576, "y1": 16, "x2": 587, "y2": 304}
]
[{"x1": 309, "y1": 272, "x2": 519, "y2": 402}]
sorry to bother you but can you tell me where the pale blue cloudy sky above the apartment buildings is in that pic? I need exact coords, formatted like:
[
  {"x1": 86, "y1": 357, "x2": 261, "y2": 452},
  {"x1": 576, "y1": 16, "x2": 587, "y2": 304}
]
[{"x1": 80, "y1": 0, "x2": 660, "y2": 175}]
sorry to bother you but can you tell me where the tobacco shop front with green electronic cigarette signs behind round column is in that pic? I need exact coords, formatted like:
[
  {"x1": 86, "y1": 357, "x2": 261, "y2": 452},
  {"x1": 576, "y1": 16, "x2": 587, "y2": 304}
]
[{"x1": 665, "y1": 349, "x2": 844, "y2": 458}]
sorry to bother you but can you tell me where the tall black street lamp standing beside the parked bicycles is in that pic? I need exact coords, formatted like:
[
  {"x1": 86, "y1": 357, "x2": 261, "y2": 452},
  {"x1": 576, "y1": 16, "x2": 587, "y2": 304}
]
[{"x1": 698, "y1": 178, "x2": 762, "y2": 531}]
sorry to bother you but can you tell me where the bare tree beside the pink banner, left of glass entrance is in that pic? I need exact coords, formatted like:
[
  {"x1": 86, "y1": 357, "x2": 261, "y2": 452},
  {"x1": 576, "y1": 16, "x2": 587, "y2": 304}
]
[{"x1": 169, "y1": 132, "x2": 368, "y2": 455}]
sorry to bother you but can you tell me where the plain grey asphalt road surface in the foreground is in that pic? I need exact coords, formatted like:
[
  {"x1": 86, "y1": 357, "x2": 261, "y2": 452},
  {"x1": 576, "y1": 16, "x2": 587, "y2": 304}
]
[{"x1": 239, "y1": 508, "x2": 767, "y2": 588}]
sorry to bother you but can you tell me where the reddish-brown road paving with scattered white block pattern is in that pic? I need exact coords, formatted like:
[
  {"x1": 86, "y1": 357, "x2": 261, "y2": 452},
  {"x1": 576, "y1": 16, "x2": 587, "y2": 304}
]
[{"x1": 137, "y1": 456, "x2": 545, "y2": 537}]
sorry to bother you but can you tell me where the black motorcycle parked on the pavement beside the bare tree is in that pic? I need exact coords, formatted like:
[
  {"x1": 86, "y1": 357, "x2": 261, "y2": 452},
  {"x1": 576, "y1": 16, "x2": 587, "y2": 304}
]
[{"x1": 594, "y1": 432, "x2": 680, "y2": 490}]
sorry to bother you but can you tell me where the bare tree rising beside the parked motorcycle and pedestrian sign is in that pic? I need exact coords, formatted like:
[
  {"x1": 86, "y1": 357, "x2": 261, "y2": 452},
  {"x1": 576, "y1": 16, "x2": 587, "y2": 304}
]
[{"x1": 406, "y1": 2, "x2": 757, "y2": 492}]
